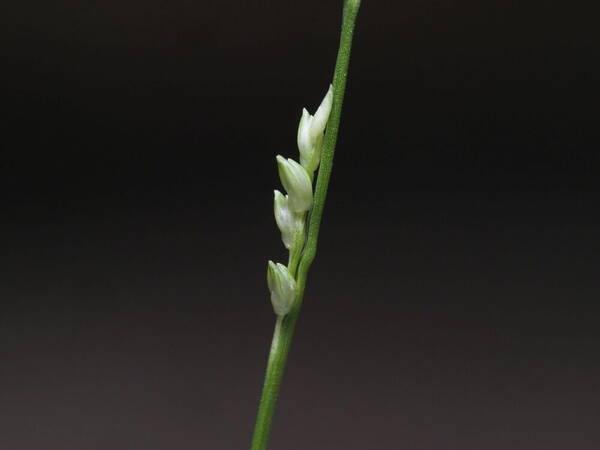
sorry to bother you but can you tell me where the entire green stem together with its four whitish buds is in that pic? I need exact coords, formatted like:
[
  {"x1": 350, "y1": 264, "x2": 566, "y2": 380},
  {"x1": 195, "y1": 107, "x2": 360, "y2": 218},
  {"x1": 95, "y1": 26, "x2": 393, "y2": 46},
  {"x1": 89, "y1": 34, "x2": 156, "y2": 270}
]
[{"x1": 251, "y1": 0, "x2": 360, "y2": 450}]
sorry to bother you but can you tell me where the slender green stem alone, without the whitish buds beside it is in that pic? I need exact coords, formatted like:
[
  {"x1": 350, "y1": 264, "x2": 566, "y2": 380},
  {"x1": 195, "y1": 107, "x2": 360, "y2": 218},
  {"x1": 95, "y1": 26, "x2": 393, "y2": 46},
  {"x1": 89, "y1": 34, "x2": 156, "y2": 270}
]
[{"x1": 251, "y1": 0, "x2": 361, "y2": 450}]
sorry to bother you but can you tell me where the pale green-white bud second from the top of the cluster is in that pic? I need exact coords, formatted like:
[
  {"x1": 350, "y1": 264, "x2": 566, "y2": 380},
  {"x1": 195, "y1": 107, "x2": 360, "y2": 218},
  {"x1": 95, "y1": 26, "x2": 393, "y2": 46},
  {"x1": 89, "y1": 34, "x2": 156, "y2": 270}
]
[{"x1": 277, "y1": 155, "x2": 312, "y2": 213}]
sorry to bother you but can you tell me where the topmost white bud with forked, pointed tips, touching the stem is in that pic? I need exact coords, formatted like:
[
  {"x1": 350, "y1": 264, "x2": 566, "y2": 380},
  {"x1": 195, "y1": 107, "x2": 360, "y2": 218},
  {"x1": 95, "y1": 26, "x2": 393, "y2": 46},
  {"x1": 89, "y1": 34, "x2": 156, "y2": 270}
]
[{"x1": 298, "y1": 85, "x2": 333, "y2": 173}]
